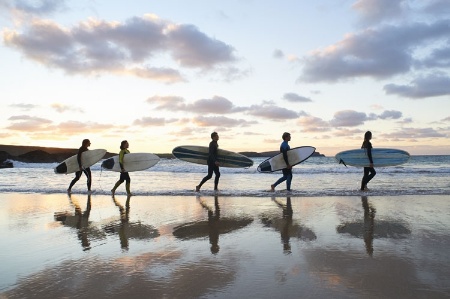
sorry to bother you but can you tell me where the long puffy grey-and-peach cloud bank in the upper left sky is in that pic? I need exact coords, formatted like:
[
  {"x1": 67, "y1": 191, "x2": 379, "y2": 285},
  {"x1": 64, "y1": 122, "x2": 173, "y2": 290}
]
[{"x1": 3, "y1": 15, "x2": 237, "y2": 83}]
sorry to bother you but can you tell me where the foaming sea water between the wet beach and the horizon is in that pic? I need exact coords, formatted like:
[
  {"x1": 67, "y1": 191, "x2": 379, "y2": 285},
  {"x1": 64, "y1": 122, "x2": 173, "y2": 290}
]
[{"x1": 0, "y1": 155, "x2": 450, "y2": 197}]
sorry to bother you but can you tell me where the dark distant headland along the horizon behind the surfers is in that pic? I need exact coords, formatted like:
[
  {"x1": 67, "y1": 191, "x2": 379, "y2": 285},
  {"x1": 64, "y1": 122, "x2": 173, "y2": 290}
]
[{"x1": 0, "y1": 144, "x2": 324, "y2": 168}]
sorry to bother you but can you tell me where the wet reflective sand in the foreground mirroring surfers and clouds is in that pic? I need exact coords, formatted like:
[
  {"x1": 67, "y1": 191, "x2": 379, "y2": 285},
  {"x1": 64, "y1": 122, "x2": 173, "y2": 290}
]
[{"x1": 0, "y1": 193, "x2": 450, "y2": 299}]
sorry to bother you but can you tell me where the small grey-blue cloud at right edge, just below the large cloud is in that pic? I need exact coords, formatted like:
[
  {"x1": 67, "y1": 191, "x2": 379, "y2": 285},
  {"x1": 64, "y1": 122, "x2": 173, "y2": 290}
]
[{"x1": 384, "y1": 73, "x2": 450, "y2": 99}]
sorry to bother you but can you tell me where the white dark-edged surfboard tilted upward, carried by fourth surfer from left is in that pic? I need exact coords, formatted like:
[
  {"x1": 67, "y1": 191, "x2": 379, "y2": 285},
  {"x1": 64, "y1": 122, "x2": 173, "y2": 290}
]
[{"x1": 258, "y1": 146, "x2": 316, "y2": 172}]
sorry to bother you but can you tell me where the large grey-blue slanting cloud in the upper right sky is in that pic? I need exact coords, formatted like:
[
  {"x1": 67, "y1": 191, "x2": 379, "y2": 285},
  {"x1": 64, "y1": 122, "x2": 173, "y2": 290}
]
[{"x1": 298, "y1": 19, "x2": 450, "y2": 82}]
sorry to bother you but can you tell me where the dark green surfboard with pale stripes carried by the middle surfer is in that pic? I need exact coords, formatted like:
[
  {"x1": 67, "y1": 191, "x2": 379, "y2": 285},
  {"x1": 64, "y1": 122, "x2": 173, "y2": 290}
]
[{"x1": 172, "y1": 145, "x2": 253, "y2": 168}]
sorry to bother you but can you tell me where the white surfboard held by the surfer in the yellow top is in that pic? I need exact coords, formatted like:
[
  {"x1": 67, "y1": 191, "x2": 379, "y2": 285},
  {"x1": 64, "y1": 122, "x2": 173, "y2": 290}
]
[{"x1": 102, "y1": 153, "x2": 159, "y2": 172}]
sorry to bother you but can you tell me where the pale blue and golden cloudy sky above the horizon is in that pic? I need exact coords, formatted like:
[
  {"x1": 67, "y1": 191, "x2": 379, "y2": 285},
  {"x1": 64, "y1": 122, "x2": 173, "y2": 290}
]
[{"x1": 0, "y1": 0, "x2": 450, "y2": 156}]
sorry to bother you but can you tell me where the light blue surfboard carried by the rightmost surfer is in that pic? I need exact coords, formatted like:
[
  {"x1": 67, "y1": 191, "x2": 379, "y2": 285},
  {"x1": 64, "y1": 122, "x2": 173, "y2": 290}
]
[{"x1": 335, "y1": 148, "x2": 409, "y2": 167}]
